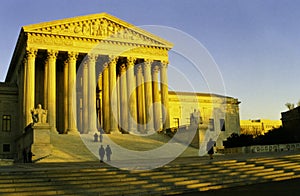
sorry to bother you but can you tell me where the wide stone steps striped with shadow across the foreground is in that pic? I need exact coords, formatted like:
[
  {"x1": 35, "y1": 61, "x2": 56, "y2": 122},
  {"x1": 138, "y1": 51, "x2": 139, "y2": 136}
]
[{"x1": 0, "y1": 152, "x2": 300, "y2": 196}]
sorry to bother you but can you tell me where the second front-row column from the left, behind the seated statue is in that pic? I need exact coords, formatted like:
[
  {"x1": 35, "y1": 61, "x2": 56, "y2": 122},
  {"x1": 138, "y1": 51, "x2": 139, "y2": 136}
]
[{"x1": 47, "y1": 50, "x2": 58, "y2": 130}]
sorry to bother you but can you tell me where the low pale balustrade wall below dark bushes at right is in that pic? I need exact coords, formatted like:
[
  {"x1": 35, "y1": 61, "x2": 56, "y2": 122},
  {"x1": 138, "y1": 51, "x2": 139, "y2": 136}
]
[{"x1": 224, "y1": 143, "x2": 300, "y2": 154}]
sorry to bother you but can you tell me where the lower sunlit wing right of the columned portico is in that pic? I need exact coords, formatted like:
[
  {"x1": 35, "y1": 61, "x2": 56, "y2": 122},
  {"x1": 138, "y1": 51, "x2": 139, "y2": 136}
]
[{"x1": 169, "y1": 91, "x2": 240, "y2": 147}]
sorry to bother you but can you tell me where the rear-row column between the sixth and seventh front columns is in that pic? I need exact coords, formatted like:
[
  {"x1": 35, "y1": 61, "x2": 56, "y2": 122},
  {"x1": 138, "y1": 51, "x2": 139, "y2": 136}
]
[{"x1": 136, "y1": 64, "x2": 145, "y2": 133}]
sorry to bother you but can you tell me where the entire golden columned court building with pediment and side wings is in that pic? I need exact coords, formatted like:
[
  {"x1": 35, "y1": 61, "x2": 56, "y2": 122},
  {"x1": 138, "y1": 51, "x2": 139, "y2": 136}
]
[{"x1": 0, "y1": 13, "x2": 240, "y2": 158}]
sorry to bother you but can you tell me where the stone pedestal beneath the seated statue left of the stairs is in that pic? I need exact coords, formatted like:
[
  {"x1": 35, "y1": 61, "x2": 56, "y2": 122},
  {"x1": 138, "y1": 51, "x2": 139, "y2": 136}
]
[{"x1": 31, "y1": 123, "x2": 52, "y2": 161}]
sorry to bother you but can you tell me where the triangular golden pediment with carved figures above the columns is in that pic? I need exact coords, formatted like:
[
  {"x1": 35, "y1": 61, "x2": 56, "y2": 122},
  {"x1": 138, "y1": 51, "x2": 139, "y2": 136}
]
[{"x1": 23, "y1": 13, "x2": 173, "y2": 48}]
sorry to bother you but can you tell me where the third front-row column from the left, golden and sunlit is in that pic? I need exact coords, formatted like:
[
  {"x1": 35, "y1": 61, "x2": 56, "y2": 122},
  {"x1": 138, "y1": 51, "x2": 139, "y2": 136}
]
[{"x1": 68, "y1": 52, "x2": 78, "y2": 133}]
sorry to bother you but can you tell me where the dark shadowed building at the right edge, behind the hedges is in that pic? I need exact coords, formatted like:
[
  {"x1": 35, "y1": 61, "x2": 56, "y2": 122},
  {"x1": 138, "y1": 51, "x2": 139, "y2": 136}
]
[{"x1": 281, "y1": 106, "x2": 300, "y2": 141}]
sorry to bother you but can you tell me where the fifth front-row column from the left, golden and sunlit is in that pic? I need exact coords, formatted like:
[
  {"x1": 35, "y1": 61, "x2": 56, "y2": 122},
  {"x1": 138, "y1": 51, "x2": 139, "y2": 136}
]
[{"x1": 107, "y1": 56, "x2": 119, "y2": 133}]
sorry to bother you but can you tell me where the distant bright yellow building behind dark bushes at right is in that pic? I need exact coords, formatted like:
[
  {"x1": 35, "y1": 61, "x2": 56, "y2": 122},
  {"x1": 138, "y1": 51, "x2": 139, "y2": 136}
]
[{"x1": 240, "y1": 119, "x2": 282, "y2": 135}]
